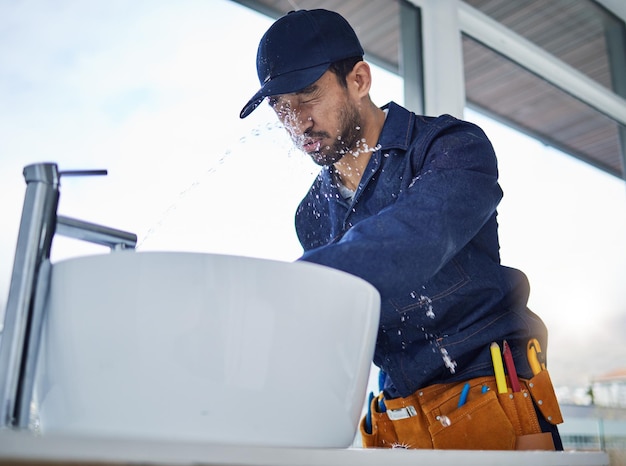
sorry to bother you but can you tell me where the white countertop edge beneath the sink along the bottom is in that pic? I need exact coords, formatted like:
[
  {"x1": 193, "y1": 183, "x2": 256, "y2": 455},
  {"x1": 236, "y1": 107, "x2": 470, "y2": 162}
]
[{"x1": 0, "y1": 430, "x2": 609, "y2": 466}]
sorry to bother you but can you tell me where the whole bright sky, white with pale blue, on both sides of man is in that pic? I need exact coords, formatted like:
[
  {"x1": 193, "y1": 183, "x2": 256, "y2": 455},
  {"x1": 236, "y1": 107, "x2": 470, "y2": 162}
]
[{"x1": 0, "y1": 0, "x2": 626, "y2": 396}]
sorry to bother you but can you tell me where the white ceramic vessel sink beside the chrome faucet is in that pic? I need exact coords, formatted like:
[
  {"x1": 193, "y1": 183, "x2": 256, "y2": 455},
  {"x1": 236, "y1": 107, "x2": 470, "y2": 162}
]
[{"x1": 35, "y1": 252, "x2": 380, "y2": 447}]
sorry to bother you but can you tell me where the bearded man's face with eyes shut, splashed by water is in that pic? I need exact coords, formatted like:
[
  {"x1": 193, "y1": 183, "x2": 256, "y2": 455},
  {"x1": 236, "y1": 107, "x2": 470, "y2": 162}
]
[{"x1": 269, "y1": 71, "x2": 362, "y2": 165}]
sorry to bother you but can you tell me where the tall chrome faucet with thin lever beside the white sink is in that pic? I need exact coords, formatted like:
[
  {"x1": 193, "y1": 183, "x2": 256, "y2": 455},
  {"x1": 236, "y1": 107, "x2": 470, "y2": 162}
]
[{"x1": 0, "y1": 163, "x2": 137, "y2": 428}]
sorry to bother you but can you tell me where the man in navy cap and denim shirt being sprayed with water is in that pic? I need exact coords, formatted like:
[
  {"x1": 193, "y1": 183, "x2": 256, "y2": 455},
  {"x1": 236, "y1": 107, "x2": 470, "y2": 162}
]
[{"x1": 240, "y1": 10, "x2": 562, "y2": 449}]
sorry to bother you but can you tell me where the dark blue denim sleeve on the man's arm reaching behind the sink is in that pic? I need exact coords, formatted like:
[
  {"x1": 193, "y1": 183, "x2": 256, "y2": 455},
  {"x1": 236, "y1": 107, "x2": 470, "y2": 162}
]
[{"x1": 301, "y1": 121, "x2": 502, "y2": 299}]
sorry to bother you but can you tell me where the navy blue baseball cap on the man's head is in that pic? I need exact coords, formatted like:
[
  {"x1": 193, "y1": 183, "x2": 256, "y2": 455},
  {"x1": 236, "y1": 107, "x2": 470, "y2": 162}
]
[{"x1": 239, "y1": 9, "x2": 363, "y2": 118}]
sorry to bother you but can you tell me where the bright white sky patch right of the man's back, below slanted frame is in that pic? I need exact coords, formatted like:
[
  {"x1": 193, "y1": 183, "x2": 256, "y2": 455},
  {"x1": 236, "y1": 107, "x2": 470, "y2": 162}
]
[{"x1": 466, "y1": 109, "x2": 626, "y2": 403}]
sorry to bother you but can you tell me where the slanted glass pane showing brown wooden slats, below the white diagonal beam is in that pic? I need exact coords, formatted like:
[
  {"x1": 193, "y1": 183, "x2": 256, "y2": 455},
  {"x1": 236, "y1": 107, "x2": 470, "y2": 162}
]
[{"x1": 463, "y1": 35, "x2": 623, "y2": 176}]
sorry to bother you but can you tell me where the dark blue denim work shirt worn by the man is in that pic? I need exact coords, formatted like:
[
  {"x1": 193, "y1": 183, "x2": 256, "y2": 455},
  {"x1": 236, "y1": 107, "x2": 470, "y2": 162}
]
[{"x1": 295, "y1": 102, "x2": 547, "y2": 397}]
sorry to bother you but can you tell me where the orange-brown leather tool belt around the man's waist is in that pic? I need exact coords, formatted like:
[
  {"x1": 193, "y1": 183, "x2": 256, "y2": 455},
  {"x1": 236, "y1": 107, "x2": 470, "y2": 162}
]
[{"x1": 361, "y1": 371, "x2": 562, "y2": 450}]
